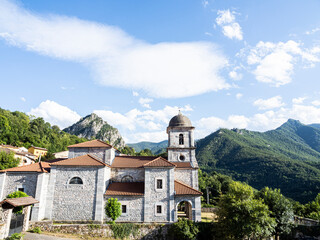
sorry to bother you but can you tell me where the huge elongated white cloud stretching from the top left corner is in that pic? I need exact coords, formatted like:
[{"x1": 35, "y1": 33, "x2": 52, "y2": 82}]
[{"x1": 0, "y1": 0, "x2": 230, "y2": 98}]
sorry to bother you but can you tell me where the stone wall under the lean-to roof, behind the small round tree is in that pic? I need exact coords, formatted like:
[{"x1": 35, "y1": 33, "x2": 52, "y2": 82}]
[{"x1": 106, "y1": 196, "x2": 144, "y2": 222}]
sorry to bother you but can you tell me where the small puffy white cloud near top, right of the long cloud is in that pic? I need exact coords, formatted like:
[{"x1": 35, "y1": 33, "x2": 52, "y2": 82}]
[{"x1": 216, "y1": 9, "x2": 243, "y2": 40}]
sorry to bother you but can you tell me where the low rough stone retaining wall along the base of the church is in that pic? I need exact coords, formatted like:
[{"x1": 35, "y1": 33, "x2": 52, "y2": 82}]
[{"x1": 29, "y1": 221, "x2": 170, "y2": 240}]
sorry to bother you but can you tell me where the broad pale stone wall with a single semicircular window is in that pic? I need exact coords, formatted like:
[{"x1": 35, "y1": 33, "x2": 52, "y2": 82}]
[{"x1": 52, "y1": 167, "x2": 99, "y2": 220}]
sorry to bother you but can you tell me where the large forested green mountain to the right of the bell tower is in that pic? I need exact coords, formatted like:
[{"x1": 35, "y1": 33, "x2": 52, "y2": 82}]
[{"x1": 196, "y1": 119, "x2": 320, "y2": 203}]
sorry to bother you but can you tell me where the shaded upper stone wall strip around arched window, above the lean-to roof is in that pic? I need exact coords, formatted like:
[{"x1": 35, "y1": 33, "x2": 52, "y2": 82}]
[{"x1": 111, "y1": 168, "x2": 144, "y2": 182}]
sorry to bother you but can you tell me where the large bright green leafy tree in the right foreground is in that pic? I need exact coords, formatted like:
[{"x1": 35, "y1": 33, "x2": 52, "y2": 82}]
[{"x1": 217, "y1": 182, "x2": 276, "y2": 240}]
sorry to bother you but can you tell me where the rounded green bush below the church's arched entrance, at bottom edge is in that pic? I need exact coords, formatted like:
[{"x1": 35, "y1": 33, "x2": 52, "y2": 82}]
[{"x1": 169, "y1": 219, "x2": 199, "y2": 240}]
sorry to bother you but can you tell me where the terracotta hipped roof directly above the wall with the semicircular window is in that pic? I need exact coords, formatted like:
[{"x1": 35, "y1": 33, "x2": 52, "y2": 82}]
[{"x1": 50, "y1": 154, "x2": 108, "y2": 166}]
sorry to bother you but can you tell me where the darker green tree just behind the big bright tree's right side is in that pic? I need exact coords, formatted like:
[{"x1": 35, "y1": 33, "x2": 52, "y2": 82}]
[{"x1": 257, "y1": 187, "x2": 294, "y2": 237}]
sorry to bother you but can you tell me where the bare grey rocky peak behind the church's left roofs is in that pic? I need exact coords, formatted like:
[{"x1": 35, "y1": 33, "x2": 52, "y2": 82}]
[{"x1": 63, "y1": 113, "x2": 125, "y2": 149}]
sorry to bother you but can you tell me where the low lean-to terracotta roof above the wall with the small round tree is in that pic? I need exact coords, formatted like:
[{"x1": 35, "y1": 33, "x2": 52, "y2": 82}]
[{"x1": 105, "y1": 182, "x2": 144, "y2": 196}]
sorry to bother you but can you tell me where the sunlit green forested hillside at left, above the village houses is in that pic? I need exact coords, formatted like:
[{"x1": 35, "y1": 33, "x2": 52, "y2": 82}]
[{"x1": 0, "y1": 108, "x2": 86, "y2": 152}]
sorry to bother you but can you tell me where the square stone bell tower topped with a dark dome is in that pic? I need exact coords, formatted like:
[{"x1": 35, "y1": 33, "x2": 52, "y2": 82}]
[{"x1": 167, "y1": 111, "x2": 198, "y2": 168}]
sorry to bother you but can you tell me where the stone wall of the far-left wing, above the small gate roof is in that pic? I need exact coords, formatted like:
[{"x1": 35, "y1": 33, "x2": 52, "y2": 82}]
[{"x1": 2, "y1": 173, "x2": 38, "y2": 198}]
